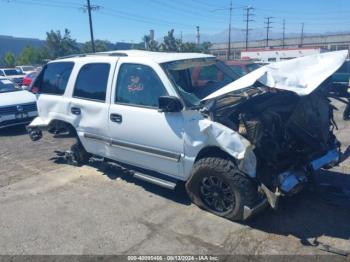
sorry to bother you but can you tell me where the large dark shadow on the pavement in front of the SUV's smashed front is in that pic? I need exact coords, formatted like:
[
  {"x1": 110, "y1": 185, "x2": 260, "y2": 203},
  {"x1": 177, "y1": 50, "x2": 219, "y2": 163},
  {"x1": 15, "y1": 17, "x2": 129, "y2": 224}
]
[{"x1": 247, "y1": 171, "x2": 350, "y2": 252}]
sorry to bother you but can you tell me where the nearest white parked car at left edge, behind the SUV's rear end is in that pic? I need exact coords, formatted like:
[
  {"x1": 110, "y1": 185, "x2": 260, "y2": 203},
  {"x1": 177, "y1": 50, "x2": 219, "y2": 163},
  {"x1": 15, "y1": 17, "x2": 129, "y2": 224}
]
[{"x1": 0, "y1": 77, "x2": 38, "y2": 129}]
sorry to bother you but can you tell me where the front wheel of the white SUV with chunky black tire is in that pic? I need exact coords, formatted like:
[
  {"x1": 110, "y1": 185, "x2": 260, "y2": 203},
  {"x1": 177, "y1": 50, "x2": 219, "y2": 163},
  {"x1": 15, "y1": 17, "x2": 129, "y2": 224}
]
[{"x1": 186, "y1": 157, "x2": 258, "y2": 221}]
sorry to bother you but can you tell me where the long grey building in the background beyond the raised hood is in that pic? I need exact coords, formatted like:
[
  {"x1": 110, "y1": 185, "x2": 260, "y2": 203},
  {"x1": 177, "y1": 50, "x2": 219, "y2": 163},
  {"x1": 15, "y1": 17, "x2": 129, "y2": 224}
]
[{"x1": 210, "y1": 34, "x2": 350, "y2": 60}]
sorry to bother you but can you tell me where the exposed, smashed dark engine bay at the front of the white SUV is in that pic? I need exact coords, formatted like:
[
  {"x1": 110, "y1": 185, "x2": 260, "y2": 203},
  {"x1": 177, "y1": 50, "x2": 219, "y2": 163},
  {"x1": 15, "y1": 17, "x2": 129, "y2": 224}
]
[{"x1": 215, "y1": 91, "x2": 338, "y2": 190}]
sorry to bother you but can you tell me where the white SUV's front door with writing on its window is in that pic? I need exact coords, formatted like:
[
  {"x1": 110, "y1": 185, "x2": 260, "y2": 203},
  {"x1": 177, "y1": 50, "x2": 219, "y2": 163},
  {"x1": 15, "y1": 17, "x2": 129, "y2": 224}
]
[{"x1": 109, "y1": 58, "x2": 183, "y2": 176}]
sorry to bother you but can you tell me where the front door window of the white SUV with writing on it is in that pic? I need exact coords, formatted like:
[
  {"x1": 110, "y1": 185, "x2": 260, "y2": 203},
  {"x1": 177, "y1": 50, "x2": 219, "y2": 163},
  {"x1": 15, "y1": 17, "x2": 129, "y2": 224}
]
[{"x1": 115, "y1": 64, "x2": 167, "y2": 107}]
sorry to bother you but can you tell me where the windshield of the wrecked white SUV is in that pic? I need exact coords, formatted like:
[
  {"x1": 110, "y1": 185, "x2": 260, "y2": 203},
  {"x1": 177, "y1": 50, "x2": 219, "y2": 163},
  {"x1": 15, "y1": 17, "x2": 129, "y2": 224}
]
[{"x1": 162, "y1": 58, "x2": 239, "y2": 107}]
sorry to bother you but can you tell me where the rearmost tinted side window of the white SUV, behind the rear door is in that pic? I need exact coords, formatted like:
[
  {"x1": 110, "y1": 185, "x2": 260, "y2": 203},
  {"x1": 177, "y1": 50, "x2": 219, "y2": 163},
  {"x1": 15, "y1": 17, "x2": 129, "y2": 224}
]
[{"x1": 38, "y1": 62, "x2": 74, "y2": 95}]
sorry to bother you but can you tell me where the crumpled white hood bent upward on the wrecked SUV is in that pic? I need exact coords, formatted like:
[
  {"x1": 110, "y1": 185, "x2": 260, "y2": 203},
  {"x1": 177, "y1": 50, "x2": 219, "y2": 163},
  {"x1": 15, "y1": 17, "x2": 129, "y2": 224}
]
[{"x1": 202, "y1": 50, "x2": 348, "y2": 101}]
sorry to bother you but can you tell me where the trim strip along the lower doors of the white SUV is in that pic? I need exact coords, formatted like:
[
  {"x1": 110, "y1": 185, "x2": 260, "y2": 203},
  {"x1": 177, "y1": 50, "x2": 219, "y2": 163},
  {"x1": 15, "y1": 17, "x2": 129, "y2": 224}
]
[{"x1": 84, "y1": 133, "x2": 181, "y2": 162}]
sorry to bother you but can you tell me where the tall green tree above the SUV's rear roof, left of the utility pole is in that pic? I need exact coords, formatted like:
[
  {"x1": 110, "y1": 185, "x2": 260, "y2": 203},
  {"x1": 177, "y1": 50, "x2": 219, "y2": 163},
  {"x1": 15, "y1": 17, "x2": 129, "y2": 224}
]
[{"x1": 46, "y1": 29, "x2": 79, "y2": 59}]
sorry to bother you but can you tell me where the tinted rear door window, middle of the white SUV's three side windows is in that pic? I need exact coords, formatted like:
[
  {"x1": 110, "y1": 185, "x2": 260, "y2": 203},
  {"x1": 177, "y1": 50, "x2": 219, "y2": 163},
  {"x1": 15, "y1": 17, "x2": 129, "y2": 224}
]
[{"x1": 73, "y1": 63, "x2": 110, "y2": 102}]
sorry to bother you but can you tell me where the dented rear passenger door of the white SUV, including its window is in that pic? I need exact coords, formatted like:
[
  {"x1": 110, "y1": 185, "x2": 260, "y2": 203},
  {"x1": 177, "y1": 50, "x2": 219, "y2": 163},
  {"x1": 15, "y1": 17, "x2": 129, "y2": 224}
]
[{"x1": 67, "y1": 58, "x2": 116, "y2": 157}]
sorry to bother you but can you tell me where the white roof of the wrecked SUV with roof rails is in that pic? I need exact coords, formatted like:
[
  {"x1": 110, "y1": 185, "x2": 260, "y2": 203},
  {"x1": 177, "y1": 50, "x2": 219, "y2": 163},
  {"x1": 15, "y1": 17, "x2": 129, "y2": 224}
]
[{"x1": 59, "y1": 50, "x2": 214, "y2": 64}]
